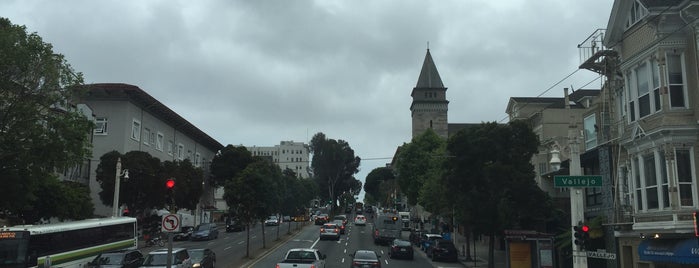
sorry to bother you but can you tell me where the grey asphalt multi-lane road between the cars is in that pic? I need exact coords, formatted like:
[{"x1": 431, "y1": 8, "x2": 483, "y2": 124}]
[{"x1": 142, "y1": 215, "x2": 465, "y2": 268}]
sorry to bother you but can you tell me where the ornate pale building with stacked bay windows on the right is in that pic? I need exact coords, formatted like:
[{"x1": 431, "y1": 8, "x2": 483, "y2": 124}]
[{"x1": 580, "y1": 0, "x2": 699, "y2": 268}]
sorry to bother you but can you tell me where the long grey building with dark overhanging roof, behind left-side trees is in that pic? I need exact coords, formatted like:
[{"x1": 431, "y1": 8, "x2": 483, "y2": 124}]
[{"x1": 81, "y1": 84, "x2": 226, "y2": 216}]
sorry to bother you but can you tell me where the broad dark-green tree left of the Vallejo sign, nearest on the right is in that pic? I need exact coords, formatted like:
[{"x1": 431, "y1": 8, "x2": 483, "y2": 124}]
[{"x1": 445, "y1": 121, "x2": 551, "y2": 267}]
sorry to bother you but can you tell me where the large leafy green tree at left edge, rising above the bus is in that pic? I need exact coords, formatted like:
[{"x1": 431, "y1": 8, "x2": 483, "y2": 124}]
[{"x1": 0, "y1": 18, "x2": 93, "y2": 223}]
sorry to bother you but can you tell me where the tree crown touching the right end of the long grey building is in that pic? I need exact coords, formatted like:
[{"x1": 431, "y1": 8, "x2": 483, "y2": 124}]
[{"x1": 211, "y1": 144, "x2": 254, "y2": 187}]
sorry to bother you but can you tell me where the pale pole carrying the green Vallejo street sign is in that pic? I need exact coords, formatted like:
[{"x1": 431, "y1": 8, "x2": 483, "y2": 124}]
[{"x1": 568, "y1": 125, "x2": 587, "y2": 268}]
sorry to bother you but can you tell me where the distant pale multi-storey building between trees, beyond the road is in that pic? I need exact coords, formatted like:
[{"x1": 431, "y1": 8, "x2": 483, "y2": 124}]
[{"x1": 246, "y1": 141, "x2": 312, "y2": 179}]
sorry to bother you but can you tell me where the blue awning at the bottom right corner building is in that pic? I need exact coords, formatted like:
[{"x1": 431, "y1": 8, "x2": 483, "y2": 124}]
[{"x1": 638, "y1": 238, "x2": 699, "y2": 264}]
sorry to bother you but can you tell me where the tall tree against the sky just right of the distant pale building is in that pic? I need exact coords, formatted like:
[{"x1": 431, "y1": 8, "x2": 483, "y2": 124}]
[{"x1": 310, "y1": 133, "x2": 361, "y2": 214}]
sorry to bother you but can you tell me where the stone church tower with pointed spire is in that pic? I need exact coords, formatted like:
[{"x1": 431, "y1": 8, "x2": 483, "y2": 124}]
[{"x1": 410, "y1": 48, "x2": 449, "y2": 139}]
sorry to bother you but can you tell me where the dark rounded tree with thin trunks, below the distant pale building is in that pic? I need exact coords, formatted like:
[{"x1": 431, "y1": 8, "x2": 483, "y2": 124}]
[{"x1": 223, "y1": 159, "x2": 281, "y2": 257}]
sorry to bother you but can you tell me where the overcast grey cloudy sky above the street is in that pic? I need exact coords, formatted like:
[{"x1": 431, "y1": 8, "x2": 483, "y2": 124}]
[{"x1": 0, "y1": 0, "x2": 613, "y2": 201}]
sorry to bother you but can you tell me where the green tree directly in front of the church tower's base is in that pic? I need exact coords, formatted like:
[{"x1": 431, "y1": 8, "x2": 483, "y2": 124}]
[{"x1": 396, "y1": 129, "x2": 445, "y2": 206}]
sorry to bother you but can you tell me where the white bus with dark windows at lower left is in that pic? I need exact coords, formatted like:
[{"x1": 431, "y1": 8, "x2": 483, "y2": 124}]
[{"x1": 0, "y1": 217, "x2": 138, "y2": 268}]
